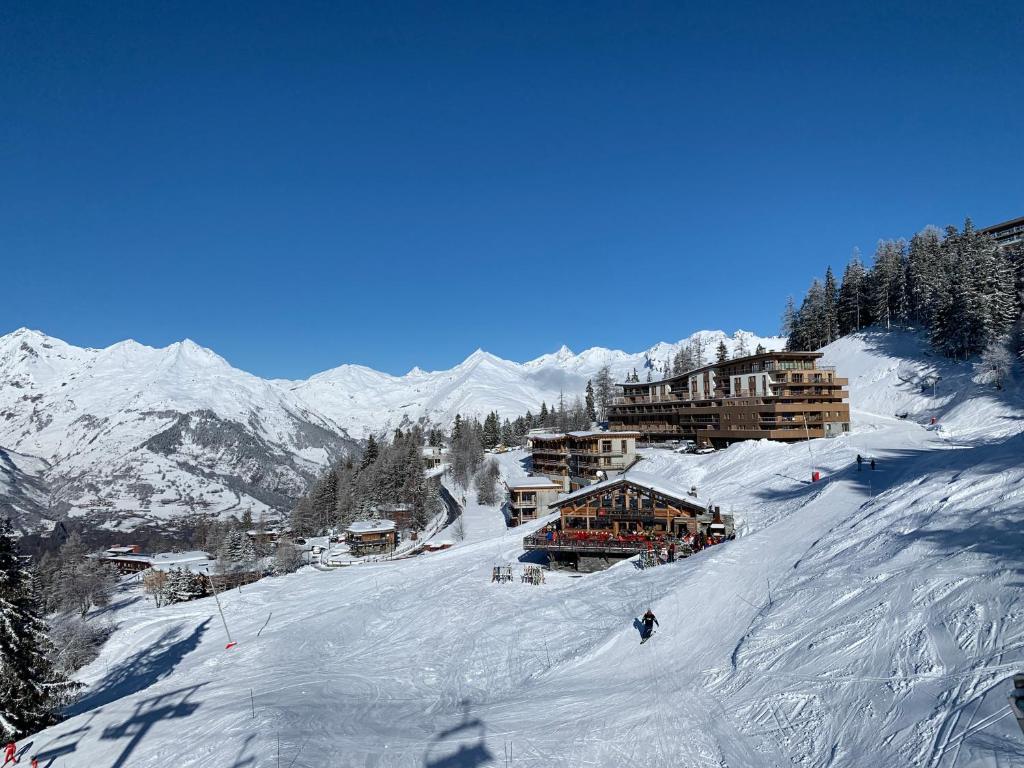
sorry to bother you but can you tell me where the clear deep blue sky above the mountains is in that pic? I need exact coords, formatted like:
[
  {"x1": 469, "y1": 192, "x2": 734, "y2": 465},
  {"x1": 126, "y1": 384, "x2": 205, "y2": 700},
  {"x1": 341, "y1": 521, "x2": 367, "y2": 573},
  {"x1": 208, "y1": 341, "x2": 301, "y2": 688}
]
[{"x1": 0, "y1": 0, "x2": 1024, "y2": 377}]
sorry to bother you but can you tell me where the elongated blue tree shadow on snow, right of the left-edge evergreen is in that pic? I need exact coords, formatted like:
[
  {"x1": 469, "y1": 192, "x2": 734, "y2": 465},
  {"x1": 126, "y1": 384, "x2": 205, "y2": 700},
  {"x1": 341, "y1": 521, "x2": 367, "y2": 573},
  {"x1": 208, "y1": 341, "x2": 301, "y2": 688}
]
[{"x1": 66, "y1": 618, "x2": 210, "y2": 717}]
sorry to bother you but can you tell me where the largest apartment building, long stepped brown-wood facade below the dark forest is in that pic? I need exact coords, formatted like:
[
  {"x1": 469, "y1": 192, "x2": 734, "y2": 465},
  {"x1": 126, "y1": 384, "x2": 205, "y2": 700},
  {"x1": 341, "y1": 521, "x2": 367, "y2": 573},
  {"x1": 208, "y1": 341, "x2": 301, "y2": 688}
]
[{"x1": 608, "y1": 352, "x2": 850, "y2": 446}]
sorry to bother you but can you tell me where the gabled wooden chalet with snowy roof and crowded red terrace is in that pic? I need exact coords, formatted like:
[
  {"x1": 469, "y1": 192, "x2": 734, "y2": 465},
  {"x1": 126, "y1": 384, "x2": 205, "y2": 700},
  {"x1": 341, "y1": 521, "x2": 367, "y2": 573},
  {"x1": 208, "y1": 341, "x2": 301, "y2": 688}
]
[{"x1": 523, "y1": 470, "x2": 735, "y2": 570}]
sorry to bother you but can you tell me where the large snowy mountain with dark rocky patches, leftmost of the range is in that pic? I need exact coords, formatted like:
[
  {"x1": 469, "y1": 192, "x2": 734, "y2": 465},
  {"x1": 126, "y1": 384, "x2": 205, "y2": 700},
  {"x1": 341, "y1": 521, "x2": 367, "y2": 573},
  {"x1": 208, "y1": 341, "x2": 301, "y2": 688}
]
[{"x1": 0, "y1": 330, "x2": 357, "y2": 529}]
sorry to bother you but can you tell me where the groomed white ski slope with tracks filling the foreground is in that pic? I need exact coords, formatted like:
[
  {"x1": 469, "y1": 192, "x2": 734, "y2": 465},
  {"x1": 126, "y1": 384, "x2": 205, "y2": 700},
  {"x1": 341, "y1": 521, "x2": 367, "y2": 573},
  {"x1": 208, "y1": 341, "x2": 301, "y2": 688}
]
[{"x1": 18, "y1": 336, "x2": 1024, "y2": 768}]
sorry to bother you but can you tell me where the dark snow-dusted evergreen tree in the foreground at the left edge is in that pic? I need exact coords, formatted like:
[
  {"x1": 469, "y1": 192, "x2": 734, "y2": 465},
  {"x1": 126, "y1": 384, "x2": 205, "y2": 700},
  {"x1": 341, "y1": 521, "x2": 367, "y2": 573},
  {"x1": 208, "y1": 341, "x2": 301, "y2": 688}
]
[{"x1": 0, "y1": 518, "x2": 77, "y2": 741}]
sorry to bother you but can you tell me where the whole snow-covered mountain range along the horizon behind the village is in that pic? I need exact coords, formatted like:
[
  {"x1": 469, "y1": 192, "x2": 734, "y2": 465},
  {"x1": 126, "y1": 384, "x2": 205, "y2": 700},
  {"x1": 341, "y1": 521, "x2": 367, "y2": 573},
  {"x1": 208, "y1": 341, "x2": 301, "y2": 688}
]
[{"x1": 0, "y1": 329, "x2": 784, "y2": 529}]
